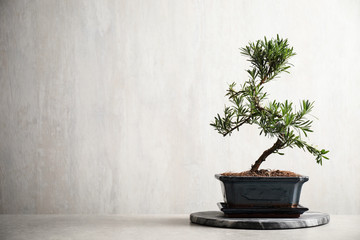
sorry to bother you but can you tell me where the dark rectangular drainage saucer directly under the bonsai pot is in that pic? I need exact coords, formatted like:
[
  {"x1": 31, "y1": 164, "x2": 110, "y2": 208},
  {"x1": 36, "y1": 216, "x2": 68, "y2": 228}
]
[{"x1": 217, "y1": 202, "x2": 309, "y2": 218}]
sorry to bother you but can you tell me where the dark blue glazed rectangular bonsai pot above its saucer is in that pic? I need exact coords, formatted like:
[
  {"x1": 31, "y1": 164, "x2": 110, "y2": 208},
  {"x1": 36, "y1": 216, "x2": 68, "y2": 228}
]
[{"x1": 215, "y1": 174, "x2": 309, "y2": 208}]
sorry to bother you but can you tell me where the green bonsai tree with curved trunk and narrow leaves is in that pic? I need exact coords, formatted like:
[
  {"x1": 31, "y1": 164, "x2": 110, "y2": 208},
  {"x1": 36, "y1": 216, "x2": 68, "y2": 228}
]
[{"x1": 210, "y1": 35, "x2": 329, "y2": 172}]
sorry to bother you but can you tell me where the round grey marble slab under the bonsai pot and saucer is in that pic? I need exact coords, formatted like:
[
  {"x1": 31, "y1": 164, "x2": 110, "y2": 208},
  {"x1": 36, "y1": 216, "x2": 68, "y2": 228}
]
[{"x1": 190, "y1": 211, "x2": 330, "y2": 230}]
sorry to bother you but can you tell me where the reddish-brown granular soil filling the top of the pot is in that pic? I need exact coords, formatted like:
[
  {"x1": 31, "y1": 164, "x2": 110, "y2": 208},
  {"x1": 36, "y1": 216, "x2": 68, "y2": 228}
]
[{"x1": 221, "y1": 169, "x2": 301, "y2": 177}]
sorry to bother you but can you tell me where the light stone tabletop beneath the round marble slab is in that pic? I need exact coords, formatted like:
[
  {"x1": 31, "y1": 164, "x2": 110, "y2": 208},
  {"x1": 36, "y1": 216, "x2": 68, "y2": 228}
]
[{"x1": 0, "y1": 214, "x2": 360, "y2": 240}]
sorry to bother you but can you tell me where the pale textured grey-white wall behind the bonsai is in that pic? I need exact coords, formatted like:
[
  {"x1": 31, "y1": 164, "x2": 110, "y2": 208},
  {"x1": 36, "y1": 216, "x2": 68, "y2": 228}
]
[{"x1": 0, "y1": 0, "x2": 360, "y2": 214}]
